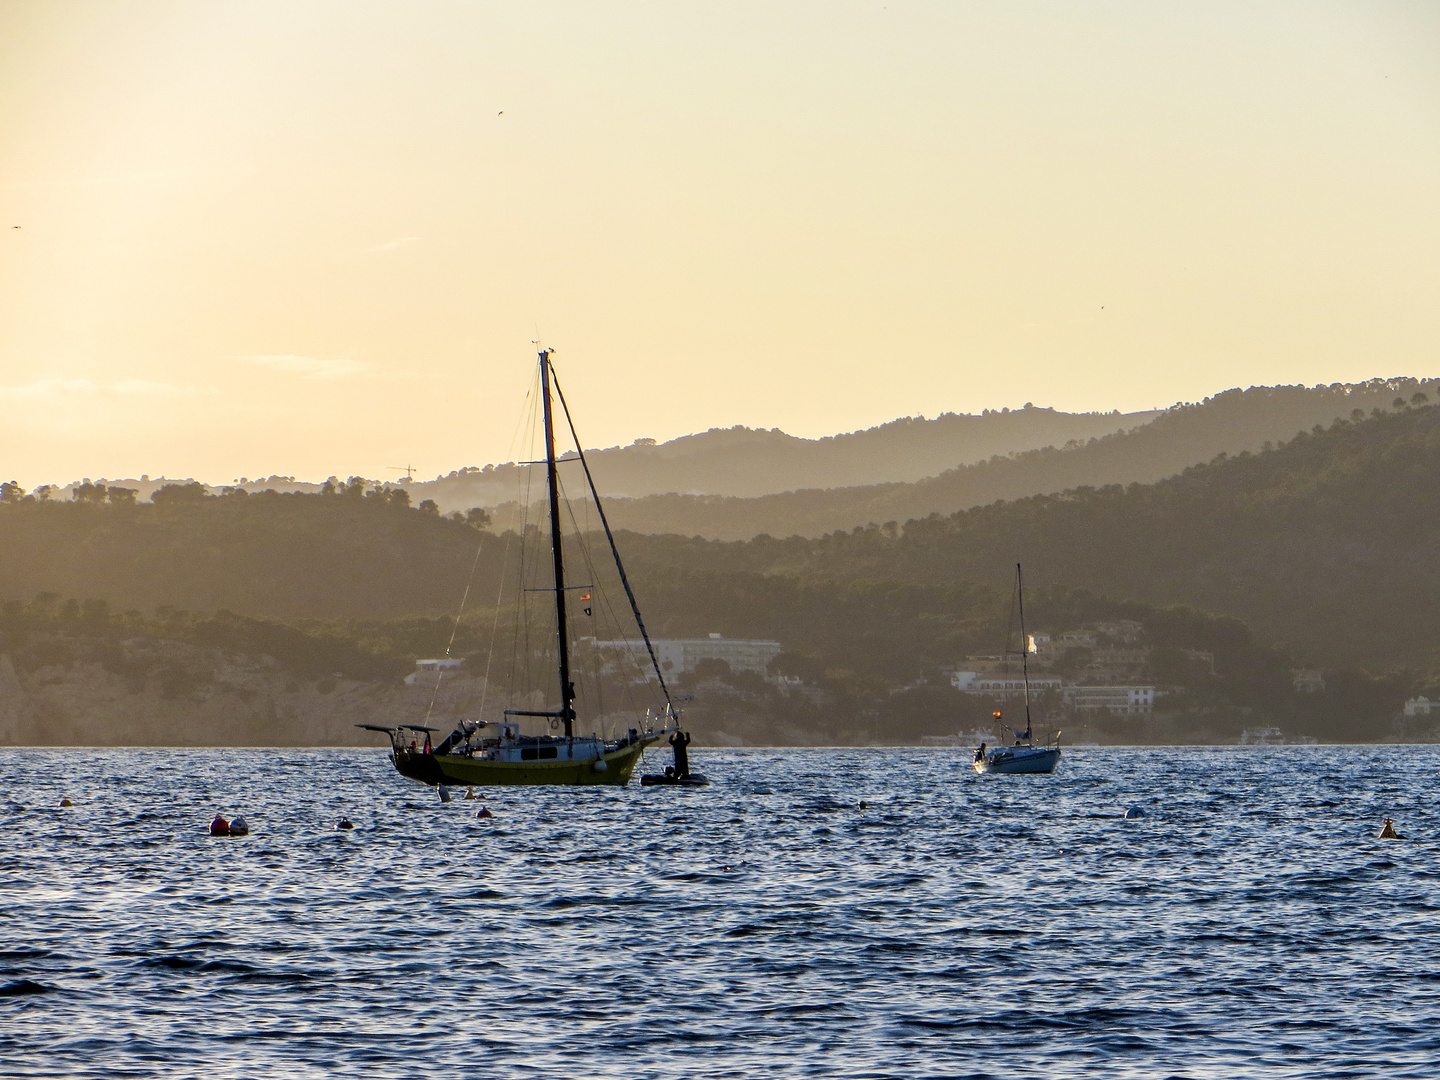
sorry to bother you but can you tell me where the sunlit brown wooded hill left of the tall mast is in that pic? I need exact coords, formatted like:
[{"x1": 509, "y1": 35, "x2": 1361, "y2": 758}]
[{"x1": 0, "y1": 494, "x2": 498, "y2": 618}]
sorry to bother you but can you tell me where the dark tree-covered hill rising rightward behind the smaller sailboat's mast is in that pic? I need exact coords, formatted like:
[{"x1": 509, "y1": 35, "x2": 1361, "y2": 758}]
[{"x1": 616, "y1": 406, "x2": 1440, "y2": 668}]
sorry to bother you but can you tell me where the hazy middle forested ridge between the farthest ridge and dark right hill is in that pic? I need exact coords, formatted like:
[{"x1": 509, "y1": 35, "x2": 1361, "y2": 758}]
[{"x1": 532, "y1": 379, "x2": 1437, "y2": 540}]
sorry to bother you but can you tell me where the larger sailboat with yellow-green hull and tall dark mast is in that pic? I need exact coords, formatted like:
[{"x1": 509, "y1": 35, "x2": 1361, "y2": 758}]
[{"x1": 356, "y1": 348, "x2": 680, "y2": 795}]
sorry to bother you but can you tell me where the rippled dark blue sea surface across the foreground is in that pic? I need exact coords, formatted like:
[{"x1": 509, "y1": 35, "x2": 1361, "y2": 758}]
[{"x1": 0, "y1": 747, "x2": 1440, "y2": 1077}]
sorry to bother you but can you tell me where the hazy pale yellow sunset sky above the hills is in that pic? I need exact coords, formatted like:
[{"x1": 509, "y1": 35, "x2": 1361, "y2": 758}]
[{"x1": 0, "y1": 0, "x2": 1440, "y2": 485}]
